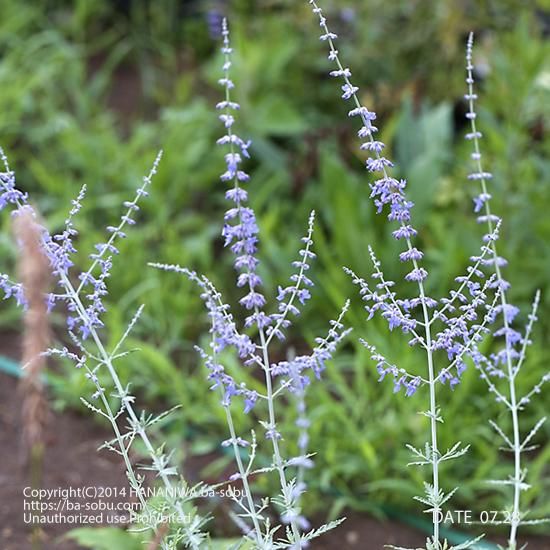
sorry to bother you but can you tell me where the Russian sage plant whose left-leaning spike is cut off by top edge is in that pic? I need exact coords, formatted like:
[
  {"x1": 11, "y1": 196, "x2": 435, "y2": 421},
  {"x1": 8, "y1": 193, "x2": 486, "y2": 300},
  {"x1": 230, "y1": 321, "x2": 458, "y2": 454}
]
[{"x1": 309, "y1": 0, "x2": 501, "y2": 550}]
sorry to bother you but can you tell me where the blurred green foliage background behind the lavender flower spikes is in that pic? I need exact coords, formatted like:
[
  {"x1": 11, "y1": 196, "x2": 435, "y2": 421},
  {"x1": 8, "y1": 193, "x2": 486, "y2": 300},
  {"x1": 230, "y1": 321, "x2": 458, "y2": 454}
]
[{"x1": 0, "y1": 0, "x2": 550, "y2": 540}]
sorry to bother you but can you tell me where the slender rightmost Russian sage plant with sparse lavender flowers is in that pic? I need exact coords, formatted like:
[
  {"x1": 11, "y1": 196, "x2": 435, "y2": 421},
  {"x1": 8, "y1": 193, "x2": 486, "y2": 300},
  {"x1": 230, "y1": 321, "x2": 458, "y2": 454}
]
[{"x1": 465, "y1": 33, "x2": 550, "y2": 550}]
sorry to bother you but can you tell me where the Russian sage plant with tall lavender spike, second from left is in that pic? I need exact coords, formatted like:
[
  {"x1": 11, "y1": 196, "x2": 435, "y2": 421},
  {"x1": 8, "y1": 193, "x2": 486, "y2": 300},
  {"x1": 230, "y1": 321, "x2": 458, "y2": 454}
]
[{"x1": 151, "y1": 20, "x2": 348, "y2": 550}]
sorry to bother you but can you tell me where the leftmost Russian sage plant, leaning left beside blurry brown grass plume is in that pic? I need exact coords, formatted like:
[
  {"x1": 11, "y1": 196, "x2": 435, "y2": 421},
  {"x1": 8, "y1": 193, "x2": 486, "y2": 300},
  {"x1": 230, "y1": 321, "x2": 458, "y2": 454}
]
[{"x1": 0, "y1": 149, "x2": 206, "y2": 549}]
